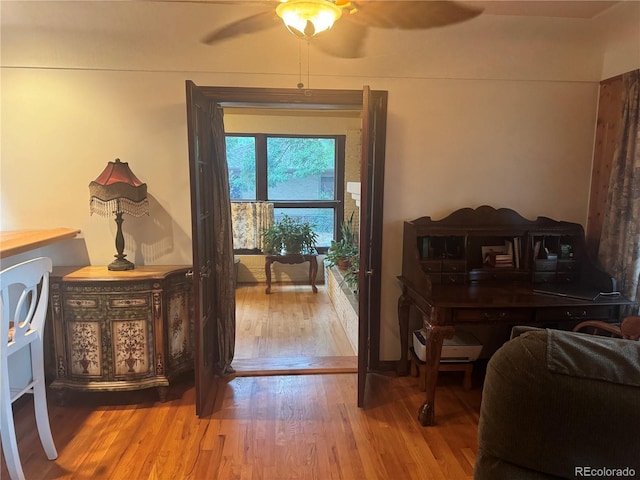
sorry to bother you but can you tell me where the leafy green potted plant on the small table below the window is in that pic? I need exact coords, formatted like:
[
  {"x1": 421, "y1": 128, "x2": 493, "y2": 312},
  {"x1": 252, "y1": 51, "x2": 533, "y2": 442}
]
[{"x1": 262, "y1": 215, "x2": 318, "y2": 255}]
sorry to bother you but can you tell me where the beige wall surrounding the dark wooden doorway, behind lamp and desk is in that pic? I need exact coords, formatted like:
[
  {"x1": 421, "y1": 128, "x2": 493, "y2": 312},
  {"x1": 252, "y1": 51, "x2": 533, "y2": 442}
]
[{"x1": 0, "y1": 1, "x2": 640, "y2": 360}]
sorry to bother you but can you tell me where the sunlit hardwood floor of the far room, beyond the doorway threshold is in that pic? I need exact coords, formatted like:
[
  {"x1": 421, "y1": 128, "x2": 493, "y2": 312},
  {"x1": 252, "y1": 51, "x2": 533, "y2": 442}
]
[{"x1": 232, "y1": 284, "x2": 358, "y2": 375}]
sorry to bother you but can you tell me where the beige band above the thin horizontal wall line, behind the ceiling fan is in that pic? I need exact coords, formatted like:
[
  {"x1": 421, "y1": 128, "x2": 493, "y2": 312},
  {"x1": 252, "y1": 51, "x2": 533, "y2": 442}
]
[{"x1": 0, "y1": 0, "x2": 640, "y2": 78}]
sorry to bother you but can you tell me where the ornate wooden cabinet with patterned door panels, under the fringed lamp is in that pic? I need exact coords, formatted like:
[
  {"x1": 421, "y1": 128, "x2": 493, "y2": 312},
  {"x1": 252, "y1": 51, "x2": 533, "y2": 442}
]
[{"x1": 50, "y1": 265, "x2": 193, "y2": 403}]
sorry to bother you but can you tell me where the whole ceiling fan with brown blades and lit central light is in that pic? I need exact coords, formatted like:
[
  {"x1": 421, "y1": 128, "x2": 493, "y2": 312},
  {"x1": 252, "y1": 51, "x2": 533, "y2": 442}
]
[{"x1": 202, "y1": 0, "x2": 482, "y2": 58}]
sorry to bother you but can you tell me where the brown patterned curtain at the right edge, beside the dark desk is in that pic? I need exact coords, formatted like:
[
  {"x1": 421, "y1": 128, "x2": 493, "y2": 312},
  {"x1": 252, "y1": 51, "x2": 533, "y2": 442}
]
[{"x1": 598, "y1": 70, "x2": 640, "y2": 306}]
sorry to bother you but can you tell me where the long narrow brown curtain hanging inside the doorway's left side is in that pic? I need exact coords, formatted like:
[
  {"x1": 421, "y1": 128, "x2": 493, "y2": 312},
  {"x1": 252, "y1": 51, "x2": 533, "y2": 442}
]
[{"x1": 211, "y1": 105, "x2": 236, "y2": 375}]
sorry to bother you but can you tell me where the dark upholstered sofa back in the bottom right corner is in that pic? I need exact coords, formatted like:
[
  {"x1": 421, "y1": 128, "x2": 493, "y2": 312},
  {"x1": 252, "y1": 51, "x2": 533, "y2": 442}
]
[{"x1": 474, "y1": 328, "x2": 640, "y2": 480}]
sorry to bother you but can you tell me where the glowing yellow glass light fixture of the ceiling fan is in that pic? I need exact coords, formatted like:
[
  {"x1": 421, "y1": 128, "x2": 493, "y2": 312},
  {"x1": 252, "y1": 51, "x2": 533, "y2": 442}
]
[{"x1": 276, "y1": 0, "x2": 342, "y2": 40}]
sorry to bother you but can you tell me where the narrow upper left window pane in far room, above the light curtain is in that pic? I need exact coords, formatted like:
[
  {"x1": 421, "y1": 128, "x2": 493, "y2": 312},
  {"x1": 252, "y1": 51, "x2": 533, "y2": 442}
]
[{"x1": 226, "y1": 136, "x2": 256, "y2": 200}]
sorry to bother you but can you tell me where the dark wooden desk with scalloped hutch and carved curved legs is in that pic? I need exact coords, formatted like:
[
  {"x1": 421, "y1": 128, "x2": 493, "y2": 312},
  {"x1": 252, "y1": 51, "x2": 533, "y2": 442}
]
[{"x1": 398, "y1": 206, "x2": 633, "y2": 425}]
